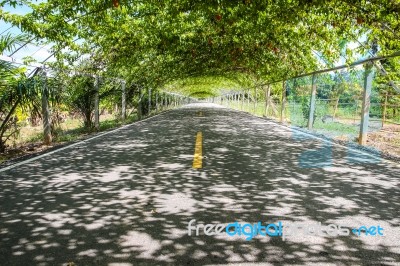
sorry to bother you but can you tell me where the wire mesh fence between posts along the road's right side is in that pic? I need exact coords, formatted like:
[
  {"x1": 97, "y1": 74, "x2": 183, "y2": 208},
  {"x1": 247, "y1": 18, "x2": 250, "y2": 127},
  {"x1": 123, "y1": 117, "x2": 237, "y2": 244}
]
[{"x1": 219, "y1": 62, "x2": 400, "y2": 156}]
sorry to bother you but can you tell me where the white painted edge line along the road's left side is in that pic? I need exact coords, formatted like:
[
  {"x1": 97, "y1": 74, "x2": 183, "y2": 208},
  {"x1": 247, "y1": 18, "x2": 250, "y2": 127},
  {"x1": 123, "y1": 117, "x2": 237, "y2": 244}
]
[{"x1": 0, "y1": 108, "x2": 173, "y2": 173}]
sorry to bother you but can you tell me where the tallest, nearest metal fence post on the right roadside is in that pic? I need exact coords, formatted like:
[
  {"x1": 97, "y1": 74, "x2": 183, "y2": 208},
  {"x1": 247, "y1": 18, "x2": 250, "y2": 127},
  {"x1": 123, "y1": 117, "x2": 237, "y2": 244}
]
[{"x1": 358, "y1": 63, "x2": 374, "y2": 145}]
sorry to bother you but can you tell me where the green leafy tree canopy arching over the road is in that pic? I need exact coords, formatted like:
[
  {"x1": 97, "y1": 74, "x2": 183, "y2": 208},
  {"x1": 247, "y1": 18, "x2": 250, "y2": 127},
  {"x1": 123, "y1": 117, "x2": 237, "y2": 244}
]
[{"x1": 0, "y1": 0, "x2": 400, "y2": 97}]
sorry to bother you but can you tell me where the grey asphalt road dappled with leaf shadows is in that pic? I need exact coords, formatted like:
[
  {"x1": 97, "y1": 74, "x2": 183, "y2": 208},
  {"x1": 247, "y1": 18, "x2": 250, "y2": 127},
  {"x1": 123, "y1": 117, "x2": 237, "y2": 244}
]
[{"x1": 0, "y1": 104, "x2": 400, "y2": 266}]
